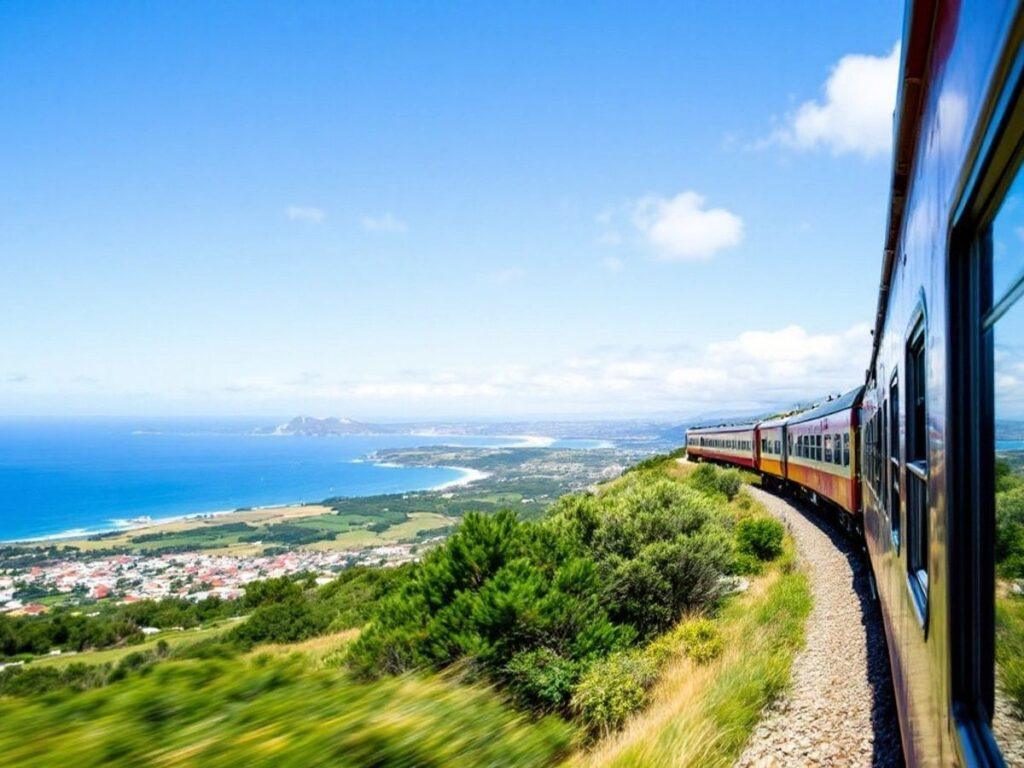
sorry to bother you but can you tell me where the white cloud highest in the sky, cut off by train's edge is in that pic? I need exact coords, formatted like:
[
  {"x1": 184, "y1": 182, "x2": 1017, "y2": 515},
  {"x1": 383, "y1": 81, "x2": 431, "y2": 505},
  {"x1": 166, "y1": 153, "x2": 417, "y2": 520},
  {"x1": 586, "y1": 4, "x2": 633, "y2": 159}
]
[{"x1": 762, "y1": 43, "x2": 900, "y2": 158}]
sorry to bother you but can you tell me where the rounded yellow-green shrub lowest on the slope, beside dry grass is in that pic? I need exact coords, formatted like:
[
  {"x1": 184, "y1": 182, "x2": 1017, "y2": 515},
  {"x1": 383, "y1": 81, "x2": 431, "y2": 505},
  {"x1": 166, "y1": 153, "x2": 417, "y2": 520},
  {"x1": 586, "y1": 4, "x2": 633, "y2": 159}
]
[{"x1": 572, "y1": 651, "x2": 657, "y2": 738}]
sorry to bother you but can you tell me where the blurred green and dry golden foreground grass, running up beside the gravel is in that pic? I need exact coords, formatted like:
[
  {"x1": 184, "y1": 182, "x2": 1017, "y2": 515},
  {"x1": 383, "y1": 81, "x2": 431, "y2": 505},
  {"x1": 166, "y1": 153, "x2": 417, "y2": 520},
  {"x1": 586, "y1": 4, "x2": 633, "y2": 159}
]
[{"x1": 0, "y1": 462, "x2": 810, "y2": 767}]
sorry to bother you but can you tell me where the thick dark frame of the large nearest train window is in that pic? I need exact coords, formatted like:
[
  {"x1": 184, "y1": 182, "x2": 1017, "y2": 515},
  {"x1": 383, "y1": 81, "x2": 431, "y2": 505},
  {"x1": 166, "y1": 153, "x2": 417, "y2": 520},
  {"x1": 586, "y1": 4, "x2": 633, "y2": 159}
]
[{"x1": 944, "y1": 31, "x2": 1024, "y2": 765}]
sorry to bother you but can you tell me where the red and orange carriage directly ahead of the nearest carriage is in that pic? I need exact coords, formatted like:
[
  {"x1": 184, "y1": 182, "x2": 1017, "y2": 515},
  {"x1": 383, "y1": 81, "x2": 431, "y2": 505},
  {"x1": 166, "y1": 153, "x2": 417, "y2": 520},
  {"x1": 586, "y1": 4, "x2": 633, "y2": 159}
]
[{"x1": 782, "y1": 387, "x2": 864, "y2": 517}]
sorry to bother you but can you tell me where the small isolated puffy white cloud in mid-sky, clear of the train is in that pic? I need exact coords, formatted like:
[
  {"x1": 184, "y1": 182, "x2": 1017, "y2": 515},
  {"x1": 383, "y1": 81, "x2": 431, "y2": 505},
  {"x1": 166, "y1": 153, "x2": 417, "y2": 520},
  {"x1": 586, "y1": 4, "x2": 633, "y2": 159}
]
[{"x1": 632, "y1": 191, "x2": 743, "y2": 260}]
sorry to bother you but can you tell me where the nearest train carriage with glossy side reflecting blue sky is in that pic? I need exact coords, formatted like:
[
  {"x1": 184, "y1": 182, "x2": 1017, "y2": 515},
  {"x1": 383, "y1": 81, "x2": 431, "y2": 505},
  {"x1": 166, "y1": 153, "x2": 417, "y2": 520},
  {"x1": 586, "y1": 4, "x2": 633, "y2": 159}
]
[{"x1": 861, "y1": 0, "x2": 1024, "y2": 766}]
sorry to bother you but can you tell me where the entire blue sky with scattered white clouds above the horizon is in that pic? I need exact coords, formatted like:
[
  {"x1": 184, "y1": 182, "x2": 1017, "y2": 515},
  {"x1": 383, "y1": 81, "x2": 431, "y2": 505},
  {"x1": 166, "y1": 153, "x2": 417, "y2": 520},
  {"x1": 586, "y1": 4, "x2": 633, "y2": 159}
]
[{"x1": 0, "y1": 2, "x2": 902, "y2": 418}]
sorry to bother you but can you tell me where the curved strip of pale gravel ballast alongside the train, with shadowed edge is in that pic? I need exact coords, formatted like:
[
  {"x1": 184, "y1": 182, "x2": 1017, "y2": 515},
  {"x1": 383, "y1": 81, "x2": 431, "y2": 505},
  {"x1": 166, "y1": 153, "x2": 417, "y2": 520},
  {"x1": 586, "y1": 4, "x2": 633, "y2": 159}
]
[{"x1": 736, "y1": 487, "x2": 903, "y2": 768}]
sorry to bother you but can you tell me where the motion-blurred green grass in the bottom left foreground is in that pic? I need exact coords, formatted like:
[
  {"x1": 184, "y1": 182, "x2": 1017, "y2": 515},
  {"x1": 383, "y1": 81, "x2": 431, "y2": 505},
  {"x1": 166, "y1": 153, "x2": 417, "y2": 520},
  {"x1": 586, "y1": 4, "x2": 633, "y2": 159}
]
[{"x1": 0, "y1": 653, "x2": 571, "y2": 768}]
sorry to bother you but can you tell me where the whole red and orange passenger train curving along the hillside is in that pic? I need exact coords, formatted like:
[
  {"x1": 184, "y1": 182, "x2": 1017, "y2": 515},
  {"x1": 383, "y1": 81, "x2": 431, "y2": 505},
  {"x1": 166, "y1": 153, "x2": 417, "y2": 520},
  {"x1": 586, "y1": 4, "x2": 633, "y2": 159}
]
[{"x1": 686, "y1": 0, "x2": 1024, "y2": 766}]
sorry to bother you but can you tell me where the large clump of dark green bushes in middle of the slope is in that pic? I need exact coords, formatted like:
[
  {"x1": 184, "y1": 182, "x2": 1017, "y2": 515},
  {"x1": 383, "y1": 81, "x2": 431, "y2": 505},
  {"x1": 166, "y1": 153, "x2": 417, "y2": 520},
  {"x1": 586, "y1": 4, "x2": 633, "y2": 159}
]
[{"x1": 350, "y1": 473, "x2": 734, "y2": 724}]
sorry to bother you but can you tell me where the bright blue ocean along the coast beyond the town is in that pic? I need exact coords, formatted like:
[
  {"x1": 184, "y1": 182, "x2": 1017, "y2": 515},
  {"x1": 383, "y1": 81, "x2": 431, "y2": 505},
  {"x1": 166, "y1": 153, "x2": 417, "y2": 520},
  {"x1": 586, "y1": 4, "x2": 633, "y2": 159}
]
[{"x1": 0, "y1": 419, "x2": 595, "y2": 542}]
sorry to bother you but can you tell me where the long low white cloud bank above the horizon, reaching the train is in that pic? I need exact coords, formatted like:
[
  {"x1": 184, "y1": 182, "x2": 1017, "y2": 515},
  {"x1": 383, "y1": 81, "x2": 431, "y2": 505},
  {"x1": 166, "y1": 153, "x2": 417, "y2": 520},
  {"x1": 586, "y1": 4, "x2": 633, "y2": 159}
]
[{"x1": 211, "y1": 324, "x2": 870, "y2": 419}]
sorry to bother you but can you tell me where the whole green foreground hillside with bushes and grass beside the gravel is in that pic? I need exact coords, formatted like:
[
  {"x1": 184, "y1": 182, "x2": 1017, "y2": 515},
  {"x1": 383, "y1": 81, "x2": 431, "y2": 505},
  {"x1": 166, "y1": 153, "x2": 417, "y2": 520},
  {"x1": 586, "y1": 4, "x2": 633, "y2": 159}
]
[{"x1": 0, "y1": 458, "x2": 809, "y2": 768}]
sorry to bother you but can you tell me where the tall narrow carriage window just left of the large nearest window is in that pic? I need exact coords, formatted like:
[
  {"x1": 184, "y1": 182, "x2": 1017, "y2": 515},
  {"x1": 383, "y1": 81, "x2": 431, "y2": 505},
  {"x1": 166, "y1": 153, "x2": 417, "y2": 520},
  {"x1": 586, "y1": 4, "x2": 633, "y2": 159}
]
[{"x1": 906, "y1": 318, "x2": 929, "y2": 624}]
